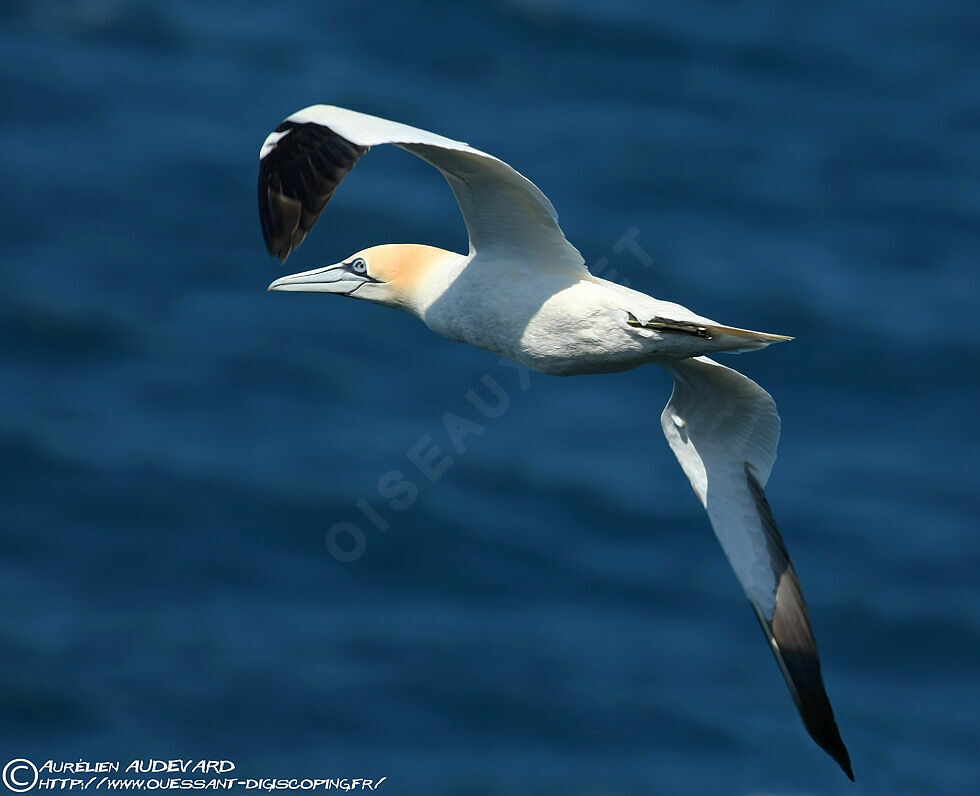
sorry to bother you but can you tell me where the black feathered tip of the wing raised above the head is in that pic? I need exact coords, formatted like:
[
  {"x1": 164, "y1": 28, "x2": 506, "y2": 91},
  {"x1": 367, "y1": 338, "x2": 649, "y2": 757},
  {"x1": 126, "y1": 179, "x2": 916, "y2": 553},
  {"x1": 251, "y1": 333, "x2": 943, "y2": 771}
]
[{"x1": 259, "y1": 120, "x2": 370, "y2": 262}]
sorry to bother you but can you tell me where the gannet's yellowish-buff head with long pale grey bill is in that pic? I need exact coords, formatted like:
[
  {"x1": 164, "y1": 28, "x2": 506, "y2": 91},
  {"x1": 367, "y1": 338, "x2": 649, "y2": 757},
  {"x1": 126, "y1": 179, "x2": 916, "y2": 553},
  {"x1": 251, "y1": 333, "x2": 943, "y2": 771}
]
[{"x1": 269, "y1": 243, "x2": 462, "y2": 312}]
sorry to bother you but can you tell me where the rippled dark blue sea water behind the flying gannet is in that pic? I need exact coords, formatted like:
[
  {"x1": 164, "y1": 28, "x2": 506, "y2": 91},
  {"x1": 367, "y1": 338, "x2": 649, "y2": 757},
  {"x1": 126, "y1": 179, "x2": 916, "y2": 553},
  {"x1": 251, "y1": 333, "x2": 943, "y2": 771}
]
[{"x1": 0, "y1": 0, "x2": 980, "y2": 794}]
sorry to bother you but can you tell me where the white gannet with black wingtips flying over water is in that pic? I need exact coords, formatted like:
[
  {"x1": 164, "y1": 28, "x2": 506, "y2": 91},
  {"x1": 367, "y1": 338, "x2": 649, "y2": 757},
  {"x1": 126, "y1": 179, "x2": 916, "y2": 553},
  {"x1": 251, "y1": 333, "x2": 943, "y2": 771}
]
[{"x1": 259, "y1": 105, "x2": 854, "y2": 780}]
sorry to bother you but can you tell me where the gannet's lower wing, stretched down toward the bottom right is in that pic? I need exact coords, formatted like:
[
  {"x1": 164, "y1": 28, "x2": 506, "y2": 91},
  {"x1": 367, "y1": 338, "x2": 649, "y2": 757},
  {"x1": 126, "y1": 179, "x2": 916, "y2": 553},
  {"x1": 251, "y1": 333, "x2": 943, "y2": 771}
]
[{"x1": 660, "y1": 357, "x2": 854, "y2": 780}]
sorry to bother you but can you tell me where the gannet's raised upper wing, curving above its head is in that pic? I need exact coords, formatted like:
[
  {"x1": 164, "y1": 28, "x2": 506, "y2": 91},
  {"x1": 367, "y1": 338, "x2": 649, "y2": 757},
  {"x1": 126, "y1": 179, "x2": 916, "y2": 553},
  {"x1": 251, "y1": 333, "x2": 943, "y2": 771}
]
[{"x1": 259, "y1": 105, "x2": 586, "y2": 272}]
